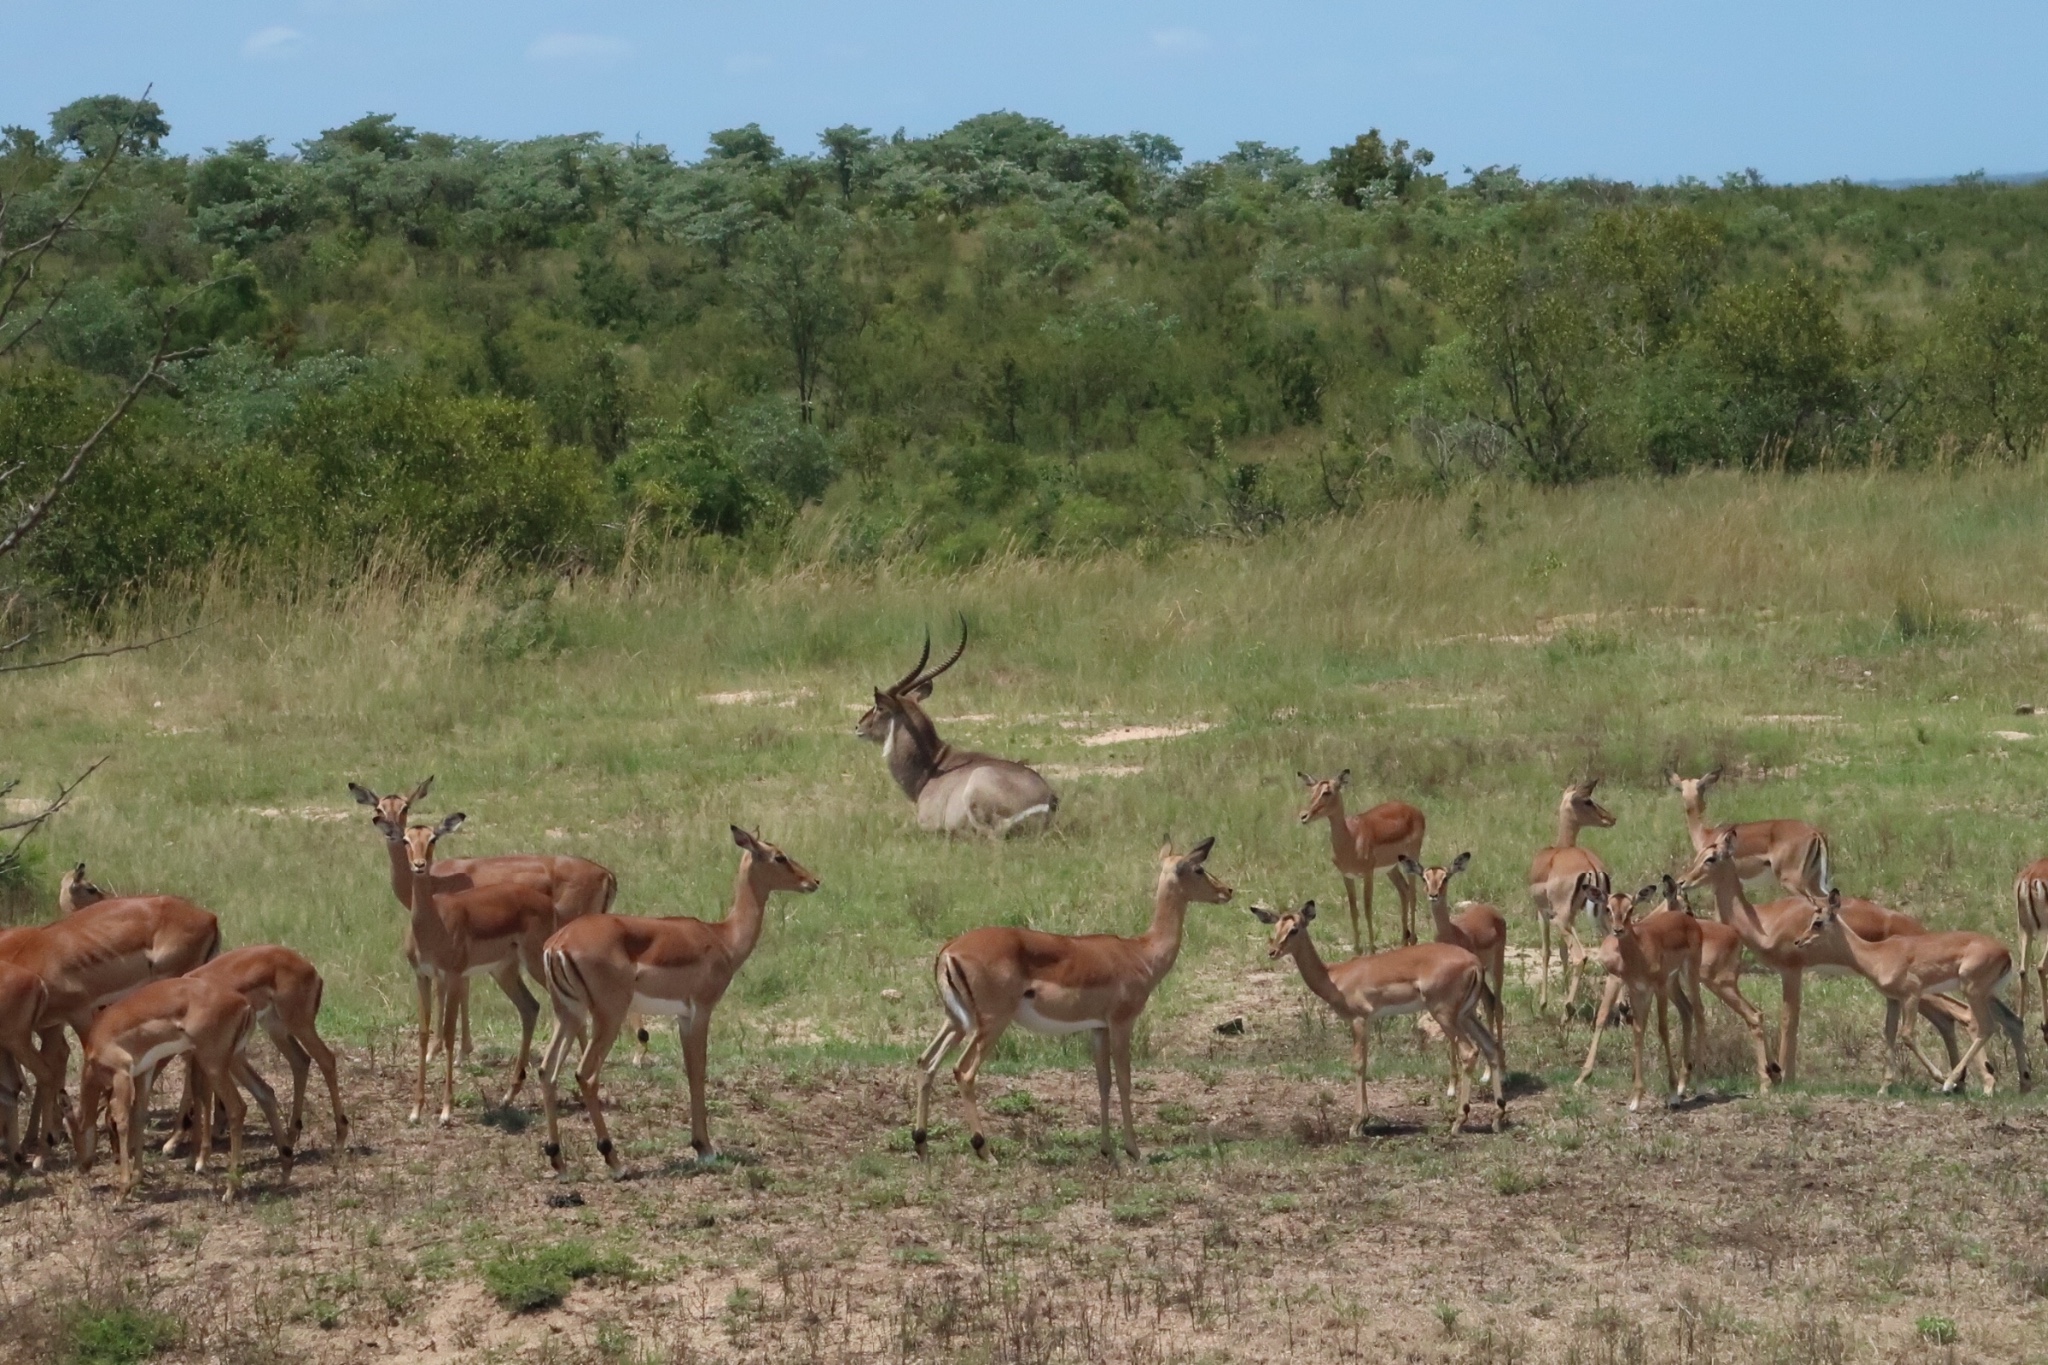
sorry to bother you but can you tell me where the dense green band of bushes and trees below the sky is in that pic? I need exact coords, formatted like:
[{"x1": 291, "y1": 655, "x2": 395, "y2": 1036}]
[{"x1": 0, "y1": 96, "x2": 2048, "y2": 602}]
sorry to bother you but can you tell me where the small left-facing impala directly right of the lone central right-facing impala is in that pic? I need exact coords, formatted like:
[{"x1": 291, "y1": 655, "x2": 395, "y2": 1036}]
[{"x1": 1251, "y1": 900, "x2": 1507, "y2": 1136}]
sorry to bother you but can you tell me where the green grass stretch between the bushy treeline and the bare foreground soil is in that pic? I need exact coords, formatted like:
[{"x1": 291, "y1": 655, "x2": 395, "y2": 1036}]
[{"x1": 0, "y1": 471, "x2": 2048, "y2": 1096}]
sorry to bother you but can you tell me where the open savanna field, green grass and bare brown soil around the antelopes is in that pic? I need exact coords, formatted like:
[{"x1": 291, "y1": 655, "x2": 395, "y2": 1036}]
[{"x1": 0, "y1": 469, "x2": 2048, "y2": 1363}]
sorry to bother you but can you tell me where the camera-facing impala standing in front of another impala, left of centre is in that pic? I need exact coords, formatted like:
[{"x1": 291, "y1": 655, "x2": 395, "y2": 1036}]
[{"x1": 401, "y1": 810, "x2": 555, "y2": 1124}]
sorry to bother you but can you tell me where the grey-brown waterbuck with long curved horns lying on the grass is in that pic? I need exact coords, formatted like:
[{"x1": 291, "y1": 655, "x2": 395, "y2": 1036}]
[{"x1": 854, "y1": 618, "x2": 1059, "y2": 837}]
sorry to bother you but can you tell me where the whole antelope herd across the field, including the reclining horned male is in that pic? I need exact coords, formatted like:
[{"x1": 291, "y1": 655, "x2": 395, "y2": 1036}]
[{"x1": 0, "y1": 624, "x2": 2048, "y2": 1199}]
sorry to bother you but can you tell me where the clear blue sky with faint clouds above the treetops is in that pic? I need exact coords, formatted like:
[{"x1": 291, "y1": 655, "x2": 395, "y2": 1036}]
[{"x1": 0, "y1": 0, "x2": 2048, "y2": 180}]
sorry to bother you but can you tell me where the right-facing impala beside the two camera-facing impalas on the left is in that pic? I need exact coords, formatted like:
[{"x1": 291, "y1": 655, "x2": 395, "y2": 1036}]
[{"x1": 541, "y1": 825, "x2": 817, "y2": 1175}]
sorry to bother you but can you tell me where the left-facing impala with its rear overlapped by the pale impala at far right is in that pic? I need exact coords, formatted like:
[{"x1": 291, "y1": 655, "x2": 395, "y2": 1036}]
[{"x1": 1677, "y1": 831, "x2": 1964, "y2": 1081}]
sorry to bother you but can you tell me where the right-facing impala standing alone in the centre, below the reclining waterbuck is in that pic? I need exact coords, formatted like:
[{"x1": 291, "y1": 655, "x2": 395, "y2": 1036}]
[{"x1": 909, "y1": 839, "x2": 1233, "y2": 1160}]
